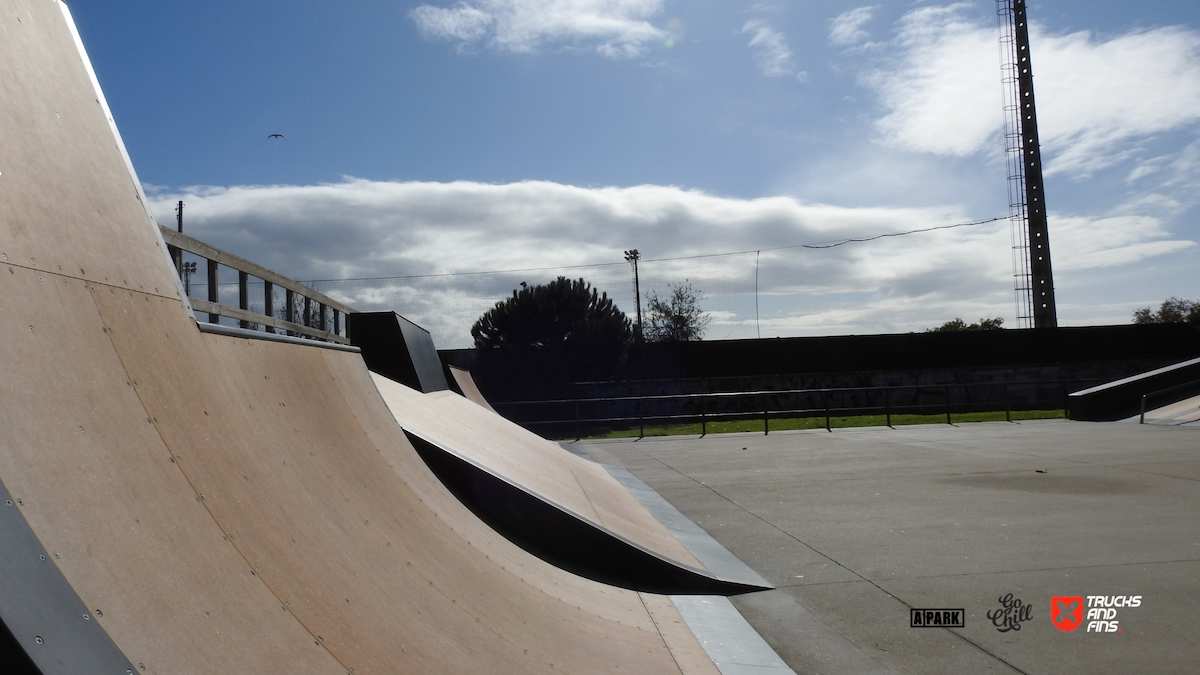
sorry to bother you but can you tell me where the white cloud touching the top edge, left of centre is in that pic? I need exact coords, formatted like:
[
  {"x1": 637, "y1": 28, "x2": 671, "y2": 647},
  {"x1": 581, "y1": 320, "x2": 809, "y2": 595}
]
[{"x1": 409, "y1": 0, "x2": 668, "y2": 56}]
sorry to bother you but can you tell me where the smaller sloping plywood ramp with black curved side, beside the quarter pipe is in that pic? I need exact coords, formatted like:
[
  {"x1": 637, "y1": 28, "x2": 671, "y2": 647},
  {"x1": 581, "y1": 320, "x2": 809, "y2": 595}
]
[{"x1": 372, "y1": 374, "x2": 768, "y2": 595}]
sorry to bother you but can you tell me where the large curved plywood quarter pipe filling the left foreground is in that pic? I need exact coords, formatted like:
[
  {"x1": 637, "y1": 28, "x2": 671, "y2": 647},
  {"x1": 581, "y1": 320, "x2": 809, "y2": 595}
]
[{"x1": 0, "y1": 0, "x2": 716, "y2": 675}]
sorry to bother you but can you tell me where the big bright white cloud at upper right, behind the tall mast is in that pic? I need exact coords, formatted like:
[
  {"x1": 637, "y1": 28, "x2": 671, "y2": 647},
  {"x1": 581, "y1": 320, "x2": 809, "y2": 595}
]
[{"x1": 864, "y1": 4, "x2": 1200, "y2": 177}]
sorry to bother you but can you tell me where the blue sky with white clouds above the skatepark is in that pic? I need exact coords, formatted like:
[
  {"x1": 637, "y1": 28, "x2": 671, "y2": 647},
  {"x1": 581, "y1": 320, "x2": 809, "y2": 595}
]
[{"x1": 71, "y1": 0, "x2": 1200, "y2": 346}]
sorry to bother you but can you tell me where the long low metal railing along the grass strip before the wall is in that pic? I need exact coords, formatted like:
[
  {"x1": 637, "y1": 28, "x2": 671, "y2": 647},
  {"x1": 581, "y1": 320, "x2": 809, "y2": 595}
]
[{"x1": 492, "y1": 380, "x2": 1094, "y2": 438}]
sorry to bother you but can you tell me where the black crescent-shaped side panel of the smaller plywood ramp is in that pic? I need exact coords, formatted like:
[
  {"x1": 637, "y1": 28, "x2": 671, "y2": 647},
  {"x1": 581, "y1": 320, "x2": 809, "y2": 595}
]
[{"x1": 404, "y1": 429, "x2": 763, "y2": 596}]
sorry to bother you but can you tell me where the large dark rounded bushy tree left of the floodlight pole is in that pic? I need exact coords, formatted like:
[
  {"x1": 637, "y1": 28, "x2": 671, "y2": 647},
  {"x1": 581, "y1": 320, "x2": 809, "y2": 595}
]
[{"x1": 470, "y1": 276, "x2": 634, "y2": 382}]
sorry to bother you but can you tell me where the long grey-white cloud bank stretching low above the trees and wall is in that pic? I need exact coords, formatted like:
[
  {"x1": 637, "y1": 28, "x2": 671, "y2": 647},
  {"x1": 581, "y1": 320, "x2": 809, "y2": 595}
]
[{"x1": 150, "y1": 178, "x2": 1195, "y2": 346}]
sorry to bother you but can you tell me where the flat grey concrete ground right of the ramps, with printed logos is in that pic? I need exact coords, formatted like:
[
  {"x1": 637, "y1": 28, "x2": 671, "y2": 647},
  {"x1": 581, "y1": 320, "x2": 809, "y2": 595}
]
[{"x1": 578, "y1": 420, "x2": 1200, "y2": 674}]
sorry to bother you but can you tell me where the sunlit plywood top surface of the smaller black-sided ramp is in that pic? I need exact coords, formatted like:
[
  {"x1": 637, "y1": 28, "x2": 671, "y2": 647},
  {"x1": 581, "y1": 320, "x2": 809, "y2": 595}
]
[{"x1": 372, "y1": 374, "x2": 703, "y2": 569}]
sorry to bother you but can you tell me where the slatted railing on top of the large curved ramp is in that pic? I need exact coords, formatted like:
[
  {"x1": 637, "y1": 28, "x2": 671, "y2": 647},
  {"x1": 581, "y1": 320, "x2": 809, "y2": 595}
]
[{"x1": 160, "y1": 226, "x2": 355, "y2": 345}]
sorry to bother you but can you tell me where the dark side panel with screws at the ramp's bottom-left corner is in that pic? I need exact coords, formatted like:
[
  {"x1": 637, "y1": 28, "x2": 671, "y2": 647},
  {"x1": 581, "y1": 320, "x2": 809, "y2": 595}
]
[{"x1": 0, "y1": 473, "x2": 138, "y2": 675}]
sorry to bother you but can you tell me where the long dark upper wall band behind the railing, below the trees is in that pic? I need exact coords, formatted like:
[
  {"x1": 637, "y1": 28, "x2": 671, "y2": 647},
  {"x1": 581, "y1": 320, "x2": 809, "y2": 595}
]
[{"x1": 439, "y1": 323, "x2": 1200, "y2": 402}]
